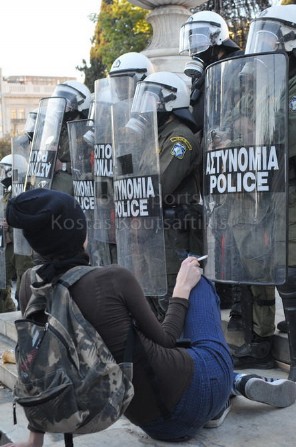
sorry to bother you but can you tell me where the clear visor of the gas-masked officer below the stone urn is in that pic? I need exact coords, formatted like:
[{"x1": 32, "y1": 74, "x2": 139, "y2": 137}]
[{"x1": 179, "y1": 22, "x2": 221, "y2": 56}]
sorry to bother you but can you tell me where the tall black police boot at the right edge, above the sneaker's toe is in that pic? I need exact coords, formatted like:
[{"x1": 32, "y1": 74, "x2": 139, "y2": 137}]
[{"x1": 278, "y1": 268, "x2": 296, "y2": 382}]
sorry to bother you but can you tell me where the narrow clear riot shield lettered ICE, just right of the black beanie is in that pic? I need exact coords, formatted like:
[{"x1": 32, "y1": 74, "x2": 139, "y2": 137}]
[{"x1": 67, "y1": 119, "x2": 100, "y2": 265}]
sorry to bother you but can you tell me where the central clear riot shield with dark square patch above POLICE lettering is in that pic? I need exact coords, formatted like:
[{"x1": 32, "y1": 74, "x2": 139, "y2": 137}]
[{"x1": 113, "y1": 77, "x2": 167, "y2": 296}]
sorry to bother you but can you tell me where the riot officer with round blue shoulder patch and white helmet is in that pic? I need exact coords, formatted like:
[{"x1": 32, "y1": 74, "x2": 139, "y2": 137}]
[{"x1": 127, "y1": 72, "x2": 202, "y2": 319}]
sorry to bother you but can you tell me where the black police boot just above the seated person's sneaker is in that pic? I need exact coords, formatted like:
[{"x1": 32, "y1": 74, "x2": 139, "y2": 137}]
[{"x1": 231, "y1": 333, "x2": 275, "y2": 369}]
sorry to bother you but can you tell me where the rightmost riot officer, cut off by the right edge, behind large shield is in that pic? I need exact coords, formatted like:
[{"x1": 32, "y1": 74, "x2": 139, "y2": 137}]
[{"x1": 242, "y1": 5, "x2": 296, "y2": 381}]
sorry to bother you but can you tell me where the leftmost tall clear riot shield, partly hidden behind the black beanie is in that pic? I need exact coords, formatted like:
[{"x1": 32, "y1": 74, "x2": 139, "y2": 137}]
[{"x1": 11, "y1": 137, "x2": 32, "y2": 256}]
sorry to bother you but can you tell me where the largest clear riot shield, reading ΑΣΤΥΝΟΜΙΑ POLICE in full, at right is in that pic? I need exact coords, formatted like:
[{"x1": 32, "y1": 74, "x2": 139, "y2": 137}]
[{"x1": 204, "y1": 53, "x2": 288, "y2": 285}]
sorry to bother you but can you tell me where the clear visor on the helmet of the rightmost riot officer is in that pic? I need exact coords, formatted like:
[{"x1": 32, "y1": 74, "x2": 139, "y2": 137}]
[{"x1": 246, "y1": 20, "x2": 285, "y2": 54}]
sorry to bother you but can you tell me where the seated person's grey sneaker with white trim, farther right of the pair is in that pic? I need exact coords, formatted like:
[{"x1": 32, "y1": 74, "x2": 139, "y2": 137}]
[{"x1": 245, "y1": 378, "x2": 296, "y2": 408}]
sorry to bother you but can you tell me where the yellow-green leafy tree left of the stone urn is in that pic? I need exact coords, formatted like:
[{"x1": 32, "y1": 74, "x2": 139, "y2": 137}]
[{"x1": 77, "y1": 0, "x2": 152, "y2": 90}]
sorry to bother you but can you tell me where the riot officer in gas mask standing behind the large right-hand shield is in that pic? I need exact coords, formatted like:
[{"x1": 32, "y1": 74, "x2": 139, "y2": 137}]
[{"x1": 180, "y1": 11, "x2": 275, "y2": 368}]
